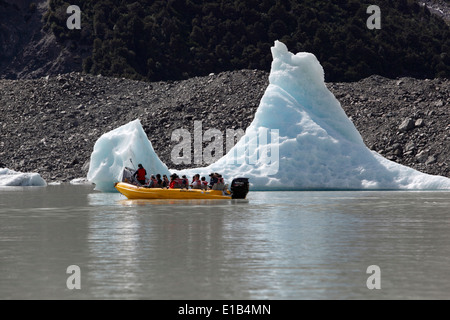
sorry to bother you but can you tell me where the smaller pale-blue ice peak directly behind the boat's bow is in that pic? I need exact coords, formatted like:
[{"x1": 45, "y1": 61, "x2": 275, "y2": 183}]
[{"x1": 87, "y1": 119, "x2": 170, "y2": 192}]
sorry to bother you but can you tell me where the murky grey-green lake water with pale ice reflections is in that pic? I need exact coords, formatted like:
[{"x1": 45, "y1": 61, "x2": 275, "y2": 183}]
[{"x1": 0, "y1": 185, "x2": 450, "y2": 300}]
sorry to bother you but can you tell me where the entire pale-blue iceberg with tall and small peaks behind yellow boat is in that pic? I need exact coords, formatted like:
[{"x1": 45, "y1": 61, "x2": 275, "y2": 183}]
[{"x1": 88, "y1": 41, "x2": 450, "y2": 190}]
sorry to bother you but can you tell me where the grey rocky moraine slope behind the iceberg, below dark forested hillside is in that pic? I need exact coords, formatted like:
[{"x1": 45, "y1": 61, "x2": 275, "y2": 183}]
[{"x1": 0, "y1": 70, "x2": 450, "y2": 181}]
